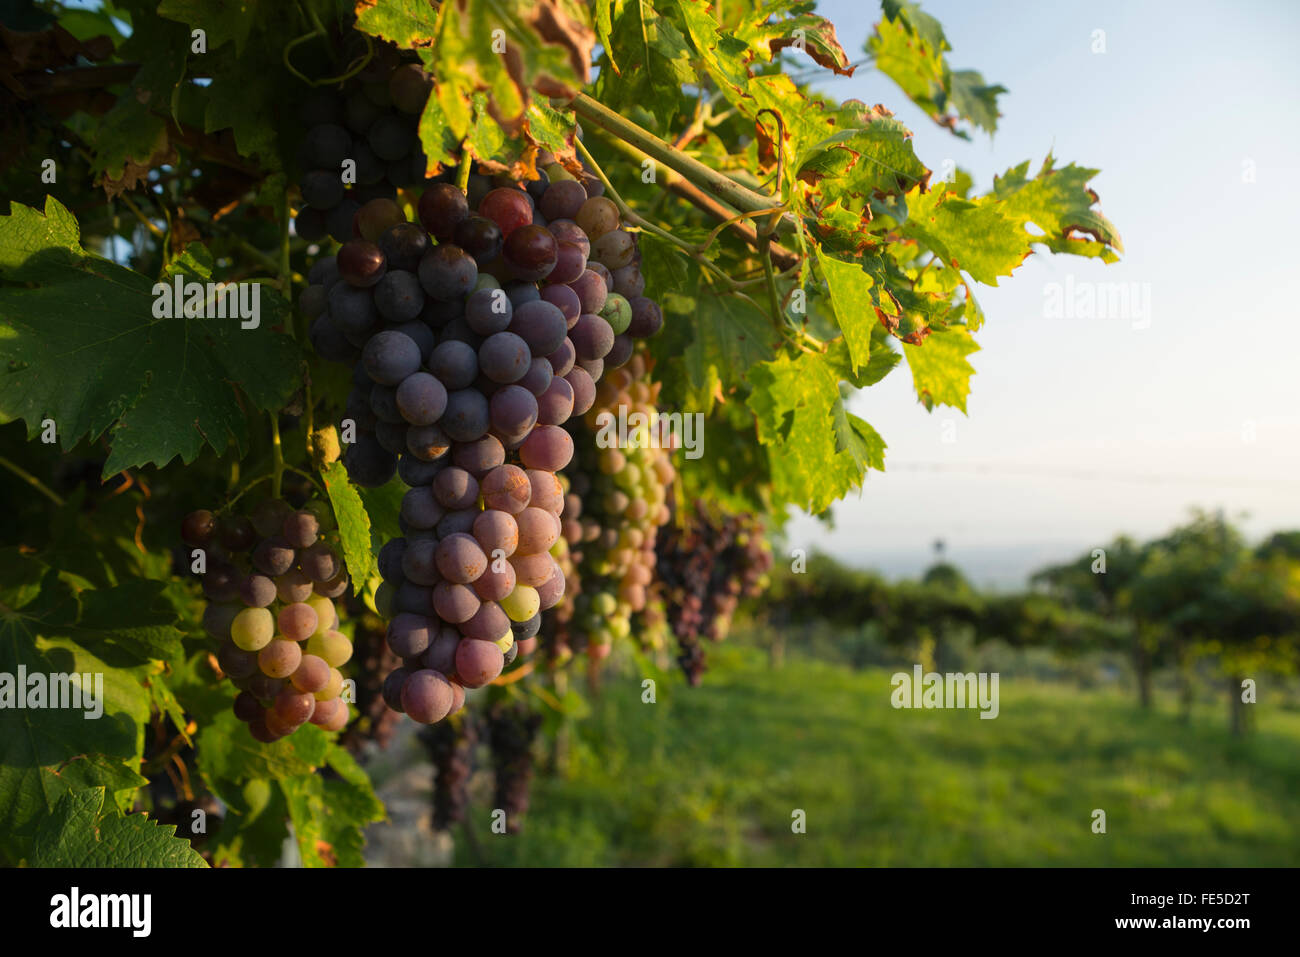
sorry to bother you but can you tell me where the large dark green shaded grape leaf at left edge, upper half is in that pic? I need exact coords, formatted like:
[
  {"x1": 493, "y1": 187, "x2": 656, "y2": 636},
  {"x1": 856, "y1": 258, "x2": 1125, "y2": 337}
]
[{"x1": 0, "y1": 196, "x2": 299, "y2": 476}]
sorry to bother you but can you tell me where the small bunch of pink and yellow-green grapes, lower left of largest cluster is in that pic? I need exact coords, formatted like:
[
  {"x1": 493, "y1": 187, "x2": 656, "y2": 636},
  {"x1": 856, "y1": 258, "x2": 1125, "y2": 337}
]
[{"x1": 181, "y1": 498, "x2": 352, "y2": 742}]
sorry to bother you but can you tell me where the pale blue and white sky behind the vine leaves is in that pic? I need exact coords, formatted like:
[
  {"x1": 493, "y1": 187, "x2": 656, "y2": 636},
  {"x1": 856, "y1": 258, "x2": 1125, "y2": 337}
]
[{"x1": 789, "y1": 0, "x2": 1300, "y2": 586}]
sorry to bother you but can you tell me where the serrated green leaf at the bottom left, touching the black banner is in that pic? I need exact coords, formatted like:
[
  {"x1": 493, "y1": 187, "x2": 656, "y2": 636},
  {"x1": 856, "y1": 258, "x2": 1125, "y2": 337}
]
[{"x1": 29, "y1": 788, "x2": 208, "y2": 867}]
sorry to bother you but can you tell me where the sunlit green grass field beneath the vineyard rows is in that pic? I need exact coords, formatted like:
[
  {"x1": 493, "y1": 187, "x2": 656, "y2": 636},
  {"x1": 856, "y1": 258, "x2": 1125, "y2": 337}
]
[{"x1": 456, "y1": 646, "x2": 1300, "y2": 866}]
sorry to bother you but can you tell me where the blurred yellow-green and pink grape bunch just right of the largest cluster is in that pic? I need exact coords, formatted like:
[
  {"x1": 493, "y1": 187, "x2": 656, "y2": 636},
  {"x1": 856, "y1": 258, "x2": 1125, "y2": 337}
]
[{"x1": 562, "y1": 352, "x2": 676, "y2": 659}]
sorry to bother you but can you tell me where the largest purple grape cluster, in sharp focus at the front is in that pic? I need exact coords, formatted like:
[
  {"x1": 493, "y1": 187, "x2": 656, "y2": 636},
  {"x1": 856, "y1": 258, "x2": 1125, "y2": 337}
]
[{"x1": 300, "y1": 158, "x2": 663, "y2": 724}]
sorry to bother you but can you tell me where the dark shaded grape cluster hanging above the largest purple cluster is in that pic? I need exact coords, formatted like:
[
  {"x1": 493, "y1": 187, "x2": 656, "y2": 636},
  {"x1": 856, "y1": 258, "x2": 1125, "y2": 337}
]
[{"x1": 295, "y1": 44, "x2": 433, "y2": 243}]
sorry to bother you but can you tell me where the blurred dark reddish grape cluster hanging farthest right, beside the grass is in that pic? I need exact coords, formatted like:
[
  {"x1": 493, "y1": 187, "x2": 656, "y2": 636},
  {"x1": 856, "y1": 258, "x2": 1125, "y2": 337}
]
[{"x1": 657, "y1": 501, "x2": 772, "y2": 685}]
